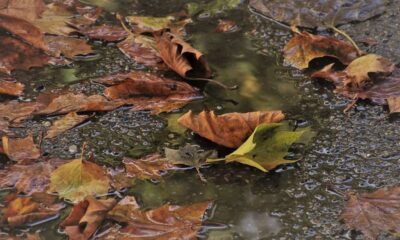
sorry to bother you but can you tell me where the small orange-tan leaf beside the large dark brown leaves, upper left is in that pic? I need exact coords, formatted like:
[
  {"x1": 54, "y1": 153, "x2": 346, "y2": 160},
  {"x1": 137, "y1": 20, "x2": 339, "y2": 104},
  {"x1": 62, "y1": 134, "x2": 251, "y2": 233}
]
[{"x1": 45, "y1": 36, "x2": 92, "y2": 58}]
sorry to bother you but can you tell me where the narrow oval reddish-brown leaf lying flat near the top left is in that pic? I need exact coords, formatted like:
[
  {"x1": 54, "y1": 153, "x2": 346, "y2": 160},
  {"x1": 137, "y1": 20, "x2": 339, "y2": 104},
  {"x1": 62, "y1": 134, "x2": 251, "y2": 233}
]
[{"x1": 78, "y1": 25, "x2": 128, "y2": 42}]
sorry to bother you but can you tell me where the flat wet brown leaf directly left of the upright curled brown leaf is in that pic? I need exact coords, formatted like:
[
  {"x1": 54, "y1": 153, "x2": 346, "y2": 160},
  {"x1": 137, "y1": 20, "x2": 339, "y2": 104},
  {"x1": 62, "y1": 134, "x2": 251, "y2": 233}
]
[{"x1": 117, "y1": 35, "x2": 165, "y2": 69}]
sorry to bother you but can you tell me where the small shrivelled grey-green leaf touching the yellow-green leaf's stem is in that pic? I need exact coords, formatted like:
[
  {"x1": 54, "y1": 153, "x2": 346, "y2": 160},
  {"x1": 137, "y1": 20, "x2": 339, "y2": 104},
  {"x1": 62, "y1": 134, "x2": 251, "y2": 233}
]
[{"x1": 165, "y1": 144, "x2": 218, "y2": 181}]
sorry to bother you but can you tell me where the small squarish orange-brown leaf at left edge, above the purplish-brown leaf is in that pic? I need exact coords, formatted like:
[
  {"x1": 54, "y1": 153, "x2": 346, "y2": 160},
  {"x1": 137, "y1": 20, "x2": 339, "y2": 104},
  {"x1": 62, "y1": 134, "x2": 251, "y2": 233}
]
[{"x1": 1, "y1": 135, "x2": 41, "y2": 162}]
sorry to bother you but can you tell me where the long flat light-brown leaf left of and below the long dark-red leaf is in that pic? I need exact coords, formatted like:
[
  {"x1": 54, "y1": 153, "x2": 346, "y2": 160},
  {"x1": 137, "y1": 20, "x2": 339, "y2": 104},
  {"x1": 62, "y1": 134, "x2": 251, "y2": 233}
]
[{"x1": 34, "y1": 93, "x2": 124, "y2": 115}]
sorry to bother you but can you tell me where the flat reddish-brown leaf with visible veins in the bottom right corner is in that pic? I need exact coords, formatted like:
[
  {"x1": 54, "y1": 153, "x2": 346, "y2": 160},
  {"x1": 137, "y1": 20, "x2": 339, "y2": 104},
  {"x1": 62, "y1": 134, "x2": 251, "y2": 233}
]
[{"x1": 341, "y1": 187, "x2": 400, "y2": 239}]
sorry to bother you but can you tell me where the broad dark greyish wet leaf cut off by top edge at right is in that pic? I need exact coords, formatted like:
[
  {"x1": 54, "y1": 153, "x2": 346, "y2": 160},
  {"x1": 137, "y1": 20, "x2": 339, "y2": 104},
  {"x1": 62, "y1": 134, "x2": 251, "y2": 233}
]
[{"x1": 250, "y1": 0, "x2": 388, "y2": 28}]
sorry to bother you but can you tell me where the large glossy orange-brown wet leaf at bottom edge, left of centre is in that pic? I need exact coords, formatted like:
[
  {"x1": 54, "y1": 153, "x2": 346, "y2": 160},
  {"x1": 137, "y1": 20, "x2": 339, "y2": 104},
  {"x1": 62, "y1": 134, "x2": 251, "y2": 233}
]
[{"x1": 101, "y1": 196, "x2": 210, "y2": 240}]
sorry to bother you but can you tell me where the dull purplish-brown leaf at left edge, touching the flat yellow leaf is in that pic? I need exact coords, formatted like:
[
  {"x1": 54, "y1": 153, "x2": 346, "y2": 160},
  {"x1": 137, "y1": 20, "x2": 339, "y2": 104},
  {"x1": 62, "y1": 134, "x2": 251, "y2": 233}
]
[{"x1": 0, "y1": 159, "x2": 65, "y2": 195}]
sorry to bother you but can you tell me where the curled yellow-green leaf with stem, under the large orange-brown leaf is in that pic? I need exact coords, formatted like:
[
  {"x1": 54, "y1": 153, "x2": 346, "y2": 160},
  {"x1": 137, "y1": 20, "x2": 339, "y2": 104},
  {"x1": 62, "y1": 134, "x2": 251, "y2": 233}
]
[{"x1": 207, "y1": 123, "x2": 304, "y2": 172}]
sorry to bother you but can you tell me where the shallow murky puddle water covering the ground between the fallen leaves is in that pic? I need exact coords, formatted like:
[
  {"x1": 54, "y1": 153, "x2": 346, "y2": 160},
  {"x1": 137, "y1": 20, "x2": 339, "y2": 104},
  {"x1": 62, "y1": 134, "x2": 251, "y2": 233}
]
[{"x1": 0, "y1": 0, "x2": 400, "y2": 239}]
